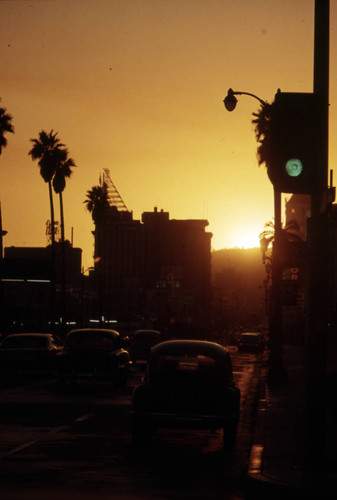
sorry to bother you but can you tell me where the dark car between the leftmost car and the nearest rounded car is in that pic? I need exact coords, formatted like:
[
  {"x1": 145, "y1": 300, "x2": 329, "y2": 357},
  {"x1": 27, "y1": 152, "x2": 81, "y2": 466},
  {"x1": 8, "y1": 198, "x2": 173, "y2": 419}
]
[{"x1": 54, "y1": 328, "x2": 130, "y2": 385}]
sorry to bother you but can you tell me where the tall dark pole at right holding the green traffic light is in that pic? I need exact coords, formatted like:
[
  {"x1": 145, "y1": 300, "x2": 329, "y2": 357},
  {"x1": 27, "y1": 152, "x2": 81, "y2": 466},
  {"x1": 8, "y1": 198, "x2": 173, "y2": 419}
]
[{"x1": 306, "y1": 0, "x2": 330, "y2": 482}]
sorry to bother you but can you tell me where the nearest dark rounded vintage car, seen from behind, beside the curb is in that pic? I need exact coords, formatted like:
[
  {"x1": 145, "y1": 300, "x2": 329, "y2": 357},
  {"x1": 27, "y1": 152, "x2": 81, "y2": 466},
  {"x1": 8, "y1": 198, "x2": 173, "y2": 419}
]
[{"x1": 131, "y1": 340, "x2": 240, "y2": 446}]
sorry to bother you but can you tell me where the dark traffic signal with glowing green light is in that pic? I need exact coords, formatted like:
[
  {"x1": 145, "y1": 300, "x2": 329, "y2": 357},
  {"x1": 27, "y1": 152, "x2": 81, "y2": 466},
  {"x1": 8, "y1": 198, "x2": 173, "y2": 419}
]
[{"x1": 268, "y1": 92, "x2": 324, "y2": 194}]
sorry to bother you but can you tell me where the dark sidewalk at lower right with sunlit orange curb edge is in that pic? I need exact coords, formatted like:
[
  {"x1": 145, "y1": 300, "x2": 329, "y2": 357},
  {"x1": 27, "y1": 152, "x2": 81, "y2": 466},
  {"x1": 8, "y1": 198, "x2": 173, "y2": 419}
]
[{"x1": 245, "y1": 346, "x2": 337, "y2": 500}]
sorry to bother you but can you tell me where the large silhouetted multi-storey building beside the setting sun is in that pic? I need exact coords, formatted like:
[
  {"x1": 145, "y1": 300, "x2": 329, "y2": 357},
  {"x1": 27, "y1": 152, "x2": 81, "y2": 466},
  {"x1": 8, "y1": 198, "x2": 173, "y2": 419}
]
[{"x1": 94, "y1": 206, "x2": 212, "y2": 324}]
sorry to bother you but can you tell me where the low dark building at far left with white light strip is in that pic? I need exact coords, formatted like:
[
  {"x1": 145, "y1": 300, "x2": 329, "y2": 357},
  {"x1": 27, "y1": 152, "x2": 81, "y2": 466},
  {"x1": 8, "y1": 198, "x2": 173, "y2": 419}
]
[{"x1": 0, "y1": 241, "x2": 82, "y2": 331}]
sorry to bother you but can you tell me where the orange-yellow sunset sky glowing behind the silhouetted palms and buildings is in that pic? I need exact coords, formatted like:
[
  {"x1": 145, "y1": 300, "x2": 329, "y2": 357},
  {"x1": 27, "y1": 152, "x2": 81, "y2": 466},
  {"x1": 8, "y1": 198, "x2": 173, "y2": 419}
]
[{"x1": 0, "y1": 0, "x2": 337, "y2": 267}]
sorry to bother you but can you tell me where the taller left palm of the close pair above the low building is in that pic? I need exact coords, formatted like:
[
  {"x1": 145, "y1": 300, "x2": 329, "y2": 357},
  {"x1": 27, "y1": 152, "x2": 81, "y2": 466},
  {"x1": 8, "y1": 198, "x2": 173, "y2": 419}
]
[{"x1": 28, "y1": 130, "x2": 64, "y2": 246}]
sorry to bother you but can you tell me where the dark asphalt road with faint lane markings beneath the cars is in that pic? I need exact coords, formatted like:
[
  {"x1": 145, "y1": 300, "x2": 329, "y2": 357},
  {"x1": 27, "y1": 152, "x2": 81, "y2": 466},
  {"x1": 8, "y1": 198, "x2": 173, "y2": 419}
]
[{"x1": 0, "y1": 347, "x2": 261, "y2": 500}]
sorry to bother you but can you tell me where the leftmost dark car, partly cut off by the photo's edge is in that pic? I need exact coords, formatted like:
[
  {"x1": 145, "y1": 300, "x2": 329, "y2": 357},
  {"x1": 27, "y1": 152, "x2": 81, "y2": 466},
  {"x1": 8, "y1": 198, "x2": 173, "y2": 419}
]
[{"x1": 0, "y1": 333, "x2": 62, "y2": 376}]
